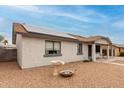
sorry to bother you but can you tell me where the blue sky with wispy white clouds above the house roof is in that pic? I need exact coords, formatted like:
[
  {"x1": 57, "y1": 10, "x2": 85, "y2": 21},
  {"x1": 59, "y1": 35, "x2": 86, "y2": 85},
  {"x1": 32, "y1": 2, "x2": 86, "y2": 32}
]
[{"x1": 0, "y1": 5, "x2": 124, "y2": 44}]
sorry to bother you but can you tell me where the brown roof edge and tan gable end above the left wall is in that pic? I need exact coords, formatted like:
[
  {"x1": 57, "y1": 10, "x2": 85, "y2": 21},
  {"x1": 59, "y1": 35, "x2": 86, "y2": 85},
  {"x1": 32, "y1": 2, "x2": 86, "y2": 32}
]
[{"x1": 12, "y1": 23, "x2": 78, "y2": 44}]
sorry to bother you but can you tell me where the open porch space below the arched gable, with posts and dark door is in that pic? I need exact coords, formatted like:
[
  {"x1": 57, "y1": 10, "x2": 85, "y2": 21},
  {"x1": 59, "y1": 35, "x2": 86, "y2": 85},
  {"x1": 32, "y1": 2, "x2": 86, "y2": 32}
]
[{"x1": 88, "y1": 43, "x2": 114, "y2": 62}]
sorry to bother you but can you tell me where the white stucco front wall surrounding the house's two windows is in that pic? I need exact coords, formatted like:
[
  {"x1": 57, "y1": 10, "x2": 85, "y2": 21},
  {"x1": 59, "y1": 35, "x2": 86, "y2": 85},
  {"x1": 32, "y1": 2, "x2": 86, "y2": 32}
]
[{"x1": 18, "y1": 37, "x2": 88, "y2": 68}]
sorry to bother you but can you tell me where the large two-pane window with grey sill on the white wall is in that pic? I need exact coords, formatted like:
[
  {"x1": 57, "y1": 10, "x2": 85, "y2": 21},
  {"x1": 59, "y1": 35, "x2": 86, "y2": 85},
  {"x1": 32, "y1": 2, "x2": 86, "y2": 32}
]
[{"x1": 45, "y1": 41, "x2": 61, "y2": 56}]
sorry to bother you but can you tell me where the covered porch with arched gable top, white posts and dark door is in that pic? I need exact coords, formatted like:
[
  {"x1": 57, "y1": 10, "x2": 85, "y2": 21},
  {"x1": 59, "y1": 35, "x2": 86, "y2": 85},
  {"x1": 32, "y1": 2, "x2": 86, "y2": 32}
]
[{"x1": 88, "y1": 38, "x2": 114, "y2": 62}]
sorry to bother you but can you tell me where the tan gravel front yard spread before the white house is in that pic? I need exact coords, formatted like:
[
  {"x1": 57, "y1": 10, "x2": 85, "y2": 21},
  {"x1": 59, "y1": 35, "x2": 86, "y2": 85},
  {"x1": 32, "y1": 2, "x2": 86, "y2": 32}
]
[{"x1": 0, "y1": 62, "x2": 124, "y2": 88}]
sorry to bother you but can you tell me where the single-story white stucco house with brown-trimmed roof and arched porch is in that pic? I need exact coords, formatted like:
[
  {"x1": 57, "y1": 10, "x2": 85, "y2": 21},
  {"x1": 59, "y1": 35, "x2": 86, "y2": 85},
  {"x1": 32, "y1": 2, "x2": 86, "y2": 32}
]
[{"x1": 12, "y1": 23, "x2": 113, "y2": 69}]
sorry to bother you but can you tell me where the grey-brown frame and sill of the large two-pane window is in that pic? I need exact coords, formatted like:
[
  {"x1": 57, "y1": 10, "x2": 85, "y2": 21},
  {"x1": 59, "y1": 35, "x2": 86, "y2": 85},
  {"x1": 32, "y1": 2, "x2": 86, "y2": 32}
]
[{"x1": 44, "y1": 40, "x2": 62, "y2": 57}]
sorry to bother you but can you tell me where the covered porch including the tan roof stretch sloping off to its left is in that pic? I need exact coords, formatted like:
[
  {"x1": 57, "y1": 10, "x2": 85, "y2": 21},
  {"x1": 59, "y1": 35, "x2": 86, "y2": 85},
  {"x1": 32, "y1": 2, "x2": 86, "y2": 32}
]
[{"x1": 72, "y1": 35, "x2": 115, "y2": 62}]
